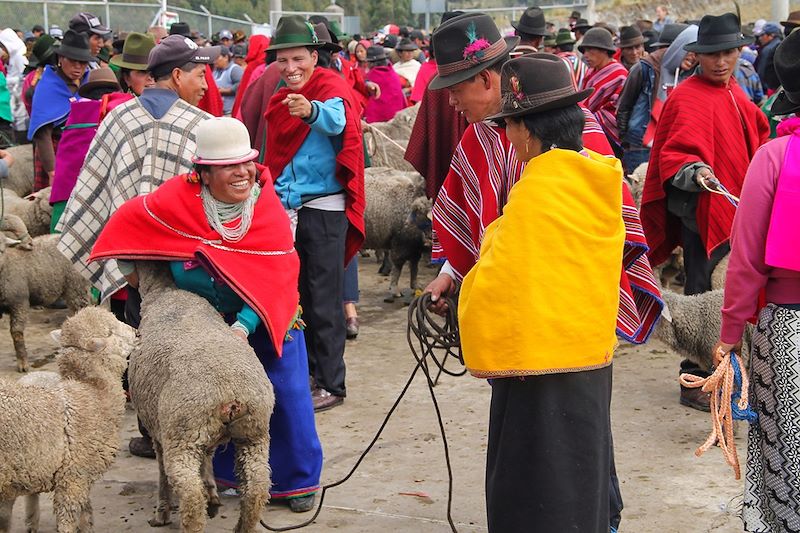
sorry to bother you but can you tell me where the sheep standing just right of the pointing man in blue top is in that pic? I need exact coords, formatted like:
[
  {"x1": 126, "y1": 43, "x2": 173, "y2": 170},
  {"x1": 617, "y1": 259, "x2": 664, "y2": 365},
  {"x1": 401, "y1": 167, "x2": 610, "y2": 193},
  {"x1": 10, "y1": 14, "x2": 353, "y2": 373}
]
[{"x1": 363, "y1": 168, "x2": 431, "y2": 302}]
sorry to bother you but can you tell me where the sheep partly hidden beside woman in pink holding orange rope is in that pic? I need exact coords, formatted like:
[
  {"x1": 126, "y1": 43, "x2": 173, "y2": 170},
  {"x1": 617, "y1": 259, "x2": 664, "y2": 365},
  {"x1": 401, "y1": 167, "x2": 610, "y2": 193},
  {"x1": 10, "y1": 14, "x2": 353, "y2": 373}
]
[{"x1": 654, "y1": 290, "x2": 752, "y2": 370}]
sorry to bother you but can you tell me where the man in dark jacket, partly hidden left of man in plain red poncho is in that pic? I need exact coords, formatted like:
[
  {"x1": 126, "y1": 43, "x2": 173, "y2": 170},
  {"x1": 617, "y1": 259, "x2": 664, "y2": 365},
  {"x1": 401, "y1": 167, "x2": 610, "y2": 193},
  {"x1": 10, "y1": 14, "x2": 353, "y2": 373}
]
[{"x1": 617, "y1": 24, "x2": 688, "y2": 174}]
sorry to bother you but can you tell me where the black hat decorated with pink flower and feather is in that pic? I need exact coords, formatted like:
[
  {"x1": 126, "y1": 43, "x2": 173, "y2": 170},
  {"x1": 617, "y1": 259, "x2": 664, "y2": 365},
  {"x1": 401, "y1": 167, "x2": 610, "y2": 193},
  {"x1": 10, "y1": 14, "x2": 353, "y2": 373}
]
[{"x1": 428, "y1": 13, "x2": 519, "y2": 90}]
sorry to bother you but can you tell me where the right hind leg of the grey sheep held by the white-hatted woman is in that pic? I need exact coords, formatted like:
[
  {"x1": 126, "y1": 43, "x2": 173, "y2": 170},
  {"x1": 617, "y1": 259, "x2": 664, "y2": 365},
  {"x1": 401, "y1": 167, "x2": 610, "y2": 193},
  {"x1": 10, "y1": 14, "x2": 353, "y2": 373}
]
[{"x1": 234, "y1": 438, "x2": 270, "y2": 533}]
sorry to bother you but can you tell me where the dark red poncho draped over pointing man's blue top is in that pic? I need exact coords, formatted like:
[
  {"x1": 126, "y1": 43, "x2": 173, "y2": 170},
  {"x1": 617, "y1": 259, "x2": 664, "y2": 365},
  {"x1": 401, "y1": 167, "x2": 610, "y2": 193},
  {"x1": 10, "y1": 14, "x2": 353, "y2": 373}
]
[{"x1": 266, "y1": 68, "x2": 366, "y2": 264}]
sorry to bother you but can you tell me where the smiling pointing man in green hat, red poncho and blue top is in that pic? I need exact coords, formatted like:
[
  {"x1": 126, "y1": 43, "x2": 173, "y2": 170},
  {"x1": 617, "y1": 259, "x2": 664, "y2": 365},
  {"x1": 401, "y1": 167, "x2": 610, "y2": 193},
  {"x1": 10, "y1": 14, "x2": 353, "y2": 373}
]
[{"x1": 265, "y1": 15, "x2": 364, "y2": 420}]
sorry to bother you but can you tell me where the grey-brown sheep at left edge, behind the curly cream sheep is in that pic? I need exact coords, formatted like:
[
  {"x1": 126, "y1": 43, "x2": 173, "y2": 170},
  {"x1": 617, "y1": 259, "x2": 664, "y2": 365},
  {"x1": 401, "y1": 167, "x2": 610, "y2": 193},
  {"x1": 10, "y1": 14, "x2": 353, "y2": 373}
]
[{"x1": 0, "y1": 235, "x2": 90, "y2": 372}]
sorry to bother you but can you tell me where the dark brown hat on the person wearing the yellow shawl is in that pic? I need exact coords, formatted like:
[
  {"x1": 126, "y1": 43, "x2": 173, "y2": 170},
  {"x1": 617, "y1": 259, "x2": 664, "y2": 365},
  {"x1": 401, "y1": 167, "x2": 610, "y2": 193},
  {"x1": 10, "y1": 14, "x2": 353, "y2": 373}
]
[{"x1": 489, "y1": 53, "x2": 594, "y2": 120}]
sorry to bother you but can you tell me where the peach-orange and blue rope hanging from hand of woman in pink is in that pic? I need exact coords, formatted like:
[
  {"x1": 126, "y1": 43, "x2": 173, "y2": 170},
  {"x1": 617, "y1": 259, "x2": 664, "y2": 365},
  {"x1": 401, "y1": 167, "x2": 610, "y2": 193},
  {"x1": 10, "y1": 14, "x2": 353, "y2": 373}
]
[{"x1": 680, "y1": 352, "x2": 758, "y2": 479}]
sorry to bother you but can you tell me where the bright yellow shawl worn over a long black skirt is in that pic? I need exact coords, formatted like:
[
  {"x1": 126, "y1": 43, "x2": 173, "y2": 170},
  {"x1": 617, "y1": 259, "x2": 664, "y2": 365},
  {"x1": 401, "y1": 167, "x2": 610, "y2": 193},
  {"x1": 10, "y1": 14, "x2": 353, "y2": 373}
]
[{"x1": 458, "y1": 149, "x2": 625, "y2": 377}]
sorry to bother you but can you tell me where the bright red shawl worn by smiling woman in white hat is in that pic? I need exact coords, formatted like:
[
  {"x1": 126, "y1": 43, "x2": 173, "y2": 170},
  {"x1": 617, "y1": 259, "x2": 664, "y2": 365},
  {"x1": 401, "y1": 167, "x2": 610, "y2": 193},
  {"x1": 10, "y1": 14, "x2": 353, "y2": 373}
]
[{"x1": 89, "y1": 166, "x2": 300, "y2": 355}]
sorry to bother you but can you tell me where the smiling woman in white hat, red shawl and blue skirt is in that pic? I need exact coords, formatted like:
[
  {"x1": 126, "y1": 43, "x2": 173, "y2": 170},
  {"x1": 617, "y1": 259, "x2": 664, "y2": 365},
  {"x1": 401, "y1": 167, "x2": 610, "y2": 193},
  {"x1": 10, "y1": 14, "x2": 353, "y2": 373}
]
[{"x1": 90, "y1": 118, "x2": 322, "y2": 512}]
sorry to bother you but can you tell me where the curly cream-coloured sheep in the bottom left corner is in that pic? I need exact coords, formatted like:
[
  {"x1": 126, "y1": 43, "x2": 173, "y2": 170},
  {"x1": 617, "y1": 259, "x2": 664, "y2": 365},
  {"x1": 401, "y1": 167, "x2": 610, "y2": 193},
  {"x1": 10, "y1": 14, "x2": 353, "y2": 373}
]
[{"x1": 0, "y1": 307, "x2": 136, "y2": 533}]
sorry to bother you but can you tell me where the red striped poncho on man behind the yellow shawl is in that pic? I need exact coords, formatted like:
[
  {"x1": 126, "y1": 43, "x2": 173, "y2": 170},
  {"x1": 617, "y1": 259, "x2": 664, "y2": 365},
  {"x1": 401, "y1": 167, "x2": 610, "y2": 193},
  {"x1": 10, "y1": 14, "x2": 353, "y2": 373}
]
[{"x1": 434, "y1": 120, "x2": 663, "y2": 343}]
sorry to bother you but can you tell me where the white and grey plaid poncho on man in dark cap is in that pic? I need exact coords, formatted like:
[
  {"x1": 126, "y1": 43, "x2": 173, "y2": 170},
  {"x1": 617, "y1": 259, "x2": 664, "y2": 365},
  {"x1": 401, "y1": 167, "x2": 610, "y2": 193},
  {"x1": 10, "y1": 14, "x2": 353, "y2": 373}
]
[{"x1": 56, "y1": 99, "x2": 210, "y2": 299}]
